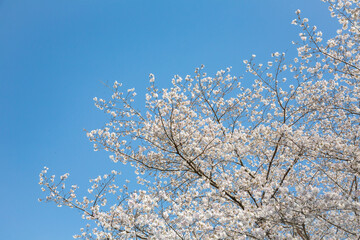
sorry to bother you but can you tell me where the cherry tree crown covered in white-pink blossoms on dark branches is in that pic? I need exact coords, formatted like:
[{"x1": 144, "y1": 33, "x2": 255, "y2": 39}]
[{"x1": 40, "y1": 0, "x2": 360, "y2": 239}]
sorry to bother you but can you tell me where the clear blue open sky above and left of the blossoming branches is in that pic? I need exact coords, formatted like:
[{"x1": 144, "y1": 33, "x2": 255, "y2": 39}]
[{"x1": 0, "y1": 0, "x2": 336, "y2": 240}]
